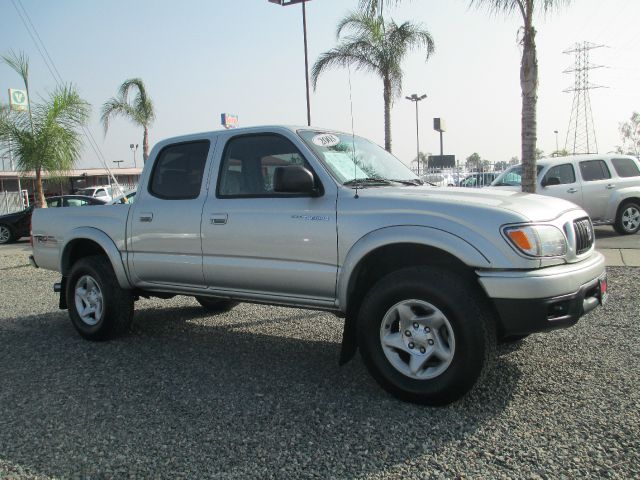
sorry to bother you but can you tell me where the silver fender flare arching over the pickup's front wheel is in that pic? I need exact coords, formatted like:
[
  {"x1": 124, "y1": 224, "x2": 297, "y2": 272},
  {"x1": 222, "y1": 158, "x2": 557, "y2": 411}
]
[{"x1": 336, "y1": 225, "x2": 491, "y2": 312}]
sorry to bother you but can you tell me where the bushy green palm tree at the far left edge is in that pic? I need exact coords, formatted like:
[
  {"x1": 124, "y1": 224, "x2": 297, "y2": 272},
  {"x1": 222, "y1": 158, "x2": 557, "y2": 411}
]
[{"x1": 0, "y1": 52, "x2": 91, "y2": 207}]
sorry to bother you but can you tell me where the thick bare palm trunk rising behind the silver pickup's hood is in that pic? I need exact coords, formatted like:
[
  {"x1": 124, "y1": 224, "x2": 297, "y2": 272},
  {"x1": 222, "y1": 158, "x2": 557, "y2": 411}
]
[{"x1": 520, "y1": 21, "x2": 538, "y2": 193}]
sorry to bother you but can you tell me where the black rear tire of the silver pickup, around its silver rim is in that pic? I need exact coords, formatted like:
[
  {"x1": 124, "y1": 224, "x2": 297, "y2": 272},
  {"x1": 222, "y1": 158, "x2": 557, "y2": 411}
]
[{"x1": 66, "y1": 255, "x2": 133, "y2": 341}]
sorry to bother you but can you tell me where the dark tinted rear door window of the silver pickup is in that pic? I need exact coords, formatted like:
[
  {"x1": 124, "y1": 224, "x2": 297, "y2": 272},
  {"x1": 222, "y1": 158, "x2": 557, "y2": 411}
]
[{"x1": 149, "y1": 140, "x2": 209, "y2": 200}]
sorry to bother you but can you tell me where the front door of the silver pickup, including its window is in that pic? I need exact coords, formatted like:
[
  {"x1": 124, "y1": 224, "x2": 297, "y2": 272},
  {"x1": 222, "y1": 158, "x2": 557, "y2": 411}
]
[{"x1": 202, "y1": 133, "x2": 337, "y2": 304}]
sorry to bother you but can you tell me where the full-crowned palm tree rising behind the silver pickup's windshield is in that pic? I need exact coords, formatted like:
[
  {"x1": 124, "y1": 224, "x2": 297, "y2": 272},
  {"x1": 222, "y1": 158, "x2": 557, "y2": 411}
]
[{"x1": 311, "y1": 13, "x2": 434, "y2": 152}]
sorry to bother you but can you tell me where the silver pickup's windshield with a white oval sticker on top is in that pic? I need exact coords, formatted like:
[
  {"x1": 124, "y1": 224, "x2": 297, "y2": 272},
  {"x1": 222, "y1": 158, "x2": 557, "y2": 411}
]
[{"x1": 298, "y1": 130, "x2": 423, "y2": 187}]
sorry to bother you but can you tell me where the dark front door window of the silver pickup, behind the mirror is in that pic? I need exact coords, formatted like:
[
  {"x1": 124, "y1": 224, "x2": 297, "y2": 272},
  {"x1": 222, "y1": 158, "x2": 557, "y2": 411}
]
[{"x1": 218, "y1": 134, "x2": 311, "y2": 197}]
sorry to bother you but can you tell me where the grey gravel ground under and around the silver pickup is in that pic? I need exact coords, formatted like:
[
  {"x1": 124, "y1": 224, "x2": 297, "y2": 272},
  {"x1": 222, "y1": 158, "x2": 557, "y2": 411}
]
[{"x1": 0, "y1": 249, "x2": 640, "y2": 479}]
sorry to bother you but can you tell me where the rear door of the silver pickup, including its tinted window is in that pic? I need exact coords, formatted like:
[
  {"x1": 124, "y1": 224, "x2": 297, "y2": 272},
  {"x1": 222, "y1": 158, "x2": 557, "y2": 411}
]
[{"x1": 128, "y1": 138, "x2": 215, "y2": 287}]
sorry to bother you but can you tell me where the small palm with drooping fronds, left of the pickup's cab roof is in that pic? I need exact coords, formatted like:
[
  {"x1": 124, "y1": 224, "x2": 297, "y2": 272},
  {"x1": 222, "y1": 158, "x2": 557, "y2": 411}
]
[{"x1": 100, "y1": 78, "x2": 156, "y2": 162}]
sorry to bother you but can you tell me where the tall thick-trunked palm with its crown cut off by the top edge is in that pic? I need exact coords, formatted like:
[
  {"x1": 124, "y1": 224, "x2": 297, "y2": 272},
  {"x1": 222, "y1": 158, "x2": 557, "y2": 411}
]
[{"x1": 469, "y1": 0, "x2": 571, "y2": 193}]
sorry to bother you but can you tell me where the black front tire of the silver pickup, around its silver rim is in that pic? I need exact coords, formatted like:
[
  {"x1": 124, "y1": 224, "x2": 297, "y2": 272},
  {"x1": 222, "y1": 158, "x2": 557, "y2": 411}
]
[{"x1": 358, "y1": 267, "x2": 496, "y2": 406}]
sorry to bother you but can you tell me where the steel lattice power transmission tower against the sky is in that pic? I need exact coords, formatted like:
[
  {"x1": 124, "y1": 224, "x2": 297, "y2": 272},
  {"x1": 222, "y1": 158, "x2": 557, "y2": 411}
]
[{"x1": 562, "y1": 42, "x2": 604, "y2": 154}]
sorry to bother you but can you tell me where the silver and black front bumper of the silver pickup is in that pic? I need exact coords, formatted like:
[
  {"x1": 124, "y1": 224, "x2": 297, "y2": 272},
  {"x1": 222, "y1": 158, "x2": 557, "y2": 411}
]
[{"x1": 478, "y1": 252, "x2": 607, "y2": 336}]
